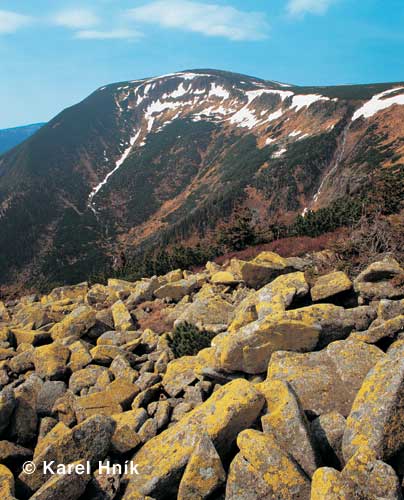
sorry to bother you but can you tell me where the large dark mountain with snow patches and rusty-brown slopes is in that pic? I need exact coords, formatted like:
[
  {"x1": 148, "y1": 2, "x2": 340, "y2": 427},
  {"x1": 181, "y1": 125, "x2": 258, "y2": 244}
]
[{"x1": 0, "y1": 70, "x2": 404, "y2": 290}]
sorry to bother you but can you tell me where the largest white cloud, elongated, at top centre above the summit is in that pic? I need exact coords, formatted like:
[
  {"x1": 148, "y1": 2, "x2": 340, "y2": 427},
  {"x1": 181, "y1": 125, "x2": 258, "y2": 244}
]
[{"x1": 127, "y1": 0, "x2": 268, "y2": 41}]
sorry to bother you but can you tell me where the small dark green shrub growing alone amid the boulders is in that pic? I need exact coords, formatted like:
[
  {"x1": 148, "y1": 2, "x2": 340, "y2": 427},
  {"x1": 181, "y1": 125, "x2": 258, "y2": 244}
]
[{"x1": 170, "y1": 322, "x2": 215, "y2": 358}]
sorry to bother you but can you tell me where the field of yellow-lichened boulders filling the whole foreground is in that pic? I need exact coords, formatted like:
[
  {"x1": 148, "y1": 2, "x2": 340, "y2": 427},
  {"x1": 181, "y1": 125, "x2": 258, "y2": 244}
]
[{"x1": 0, "y1": 251, "x2": 404, "y2": 500}]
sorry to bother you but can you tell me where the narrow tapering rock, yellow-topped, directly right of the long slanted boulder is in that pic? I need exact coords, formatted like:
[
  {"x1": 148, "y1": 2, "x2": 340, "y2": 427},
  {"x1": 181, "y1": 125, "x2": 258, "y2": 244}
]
[{"x1": 257, "y1": 380, "x2": 320, "y2": 477}]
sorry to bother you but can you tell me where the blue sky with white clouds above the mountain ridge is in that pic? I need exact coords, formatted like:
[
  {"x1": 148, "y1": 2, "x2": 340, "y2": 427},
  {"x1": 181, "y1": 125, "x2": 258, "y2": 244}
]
[{"x1": 0, "y1": 0, "x2": 404, "y2": 128}]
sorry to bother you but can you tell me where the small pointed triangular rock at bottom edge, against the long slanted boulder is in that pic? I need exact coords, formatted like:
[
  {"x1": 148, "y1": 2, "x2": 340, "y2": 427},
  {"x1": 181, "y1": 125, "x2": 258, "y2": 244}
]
[{"x1": 177, "y1": 434, "x2": 226, "y2": 500}]
